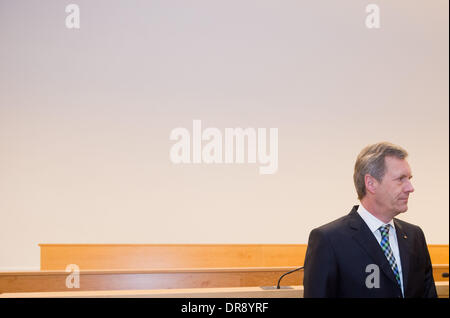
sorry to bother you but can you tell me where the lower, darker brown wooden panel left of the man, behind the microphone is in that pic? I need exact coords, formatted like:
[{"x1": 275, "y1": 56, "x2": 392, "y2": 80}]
[{"x1": 0, "y1": 267, "x2": 303, "y2": 293}]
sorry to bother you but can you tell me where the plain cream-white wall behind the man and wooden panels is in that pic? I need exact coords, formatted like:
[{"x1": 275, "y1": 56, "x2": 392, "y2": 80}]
[{"x1": 0, "y1": 0, "x2": 449, "y2": 270}]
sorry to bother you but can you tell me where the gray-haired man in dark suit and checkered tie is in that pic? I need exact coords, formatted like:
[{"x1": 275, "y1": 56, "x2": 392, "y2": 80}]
[{"x1": 303, "y1": 142, "x2": 437, "y2": 298}]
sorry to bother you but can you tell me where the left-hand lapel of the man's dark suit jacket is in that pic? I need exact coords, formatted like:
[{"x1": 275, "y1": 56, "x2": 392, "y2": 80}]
[{"x1": 349, "y1": 206, "x2": 403, "y2": 286}]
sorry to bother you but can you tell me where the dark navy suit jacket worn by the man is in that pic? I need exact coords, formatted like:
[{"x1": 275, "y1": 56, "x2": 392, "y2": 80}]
[{"x1": 303, "y1": 205, "x2": 437, "y2": 298}]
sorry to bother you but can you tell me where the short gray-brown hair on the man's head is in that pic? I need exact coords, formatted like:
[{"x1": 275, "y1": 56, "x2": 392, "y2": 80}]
[{"x1": 353, "y1": 142, "x2": 408, "y2": 200}]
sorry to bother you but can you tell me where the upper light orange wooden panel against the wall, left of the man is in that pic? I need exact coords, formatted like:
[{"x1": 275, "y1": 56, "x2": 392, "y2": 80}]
[{"x1": 40, "y1": 244, "x2": 306, "y2": 270}]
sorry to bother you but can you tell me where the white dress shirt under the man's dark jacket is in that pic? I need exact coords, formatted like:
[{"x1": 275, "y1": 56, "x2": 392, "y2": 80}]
[{"x1": 358, "y1": 204, "x2": 405, "y2": 295}]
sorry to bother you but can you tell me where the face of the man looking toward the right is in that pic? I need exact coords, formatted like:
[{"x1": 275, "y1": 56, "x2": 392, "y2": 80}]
[{"x1": 375, "y1": 157, "x2": 414, "y2": 217}]
